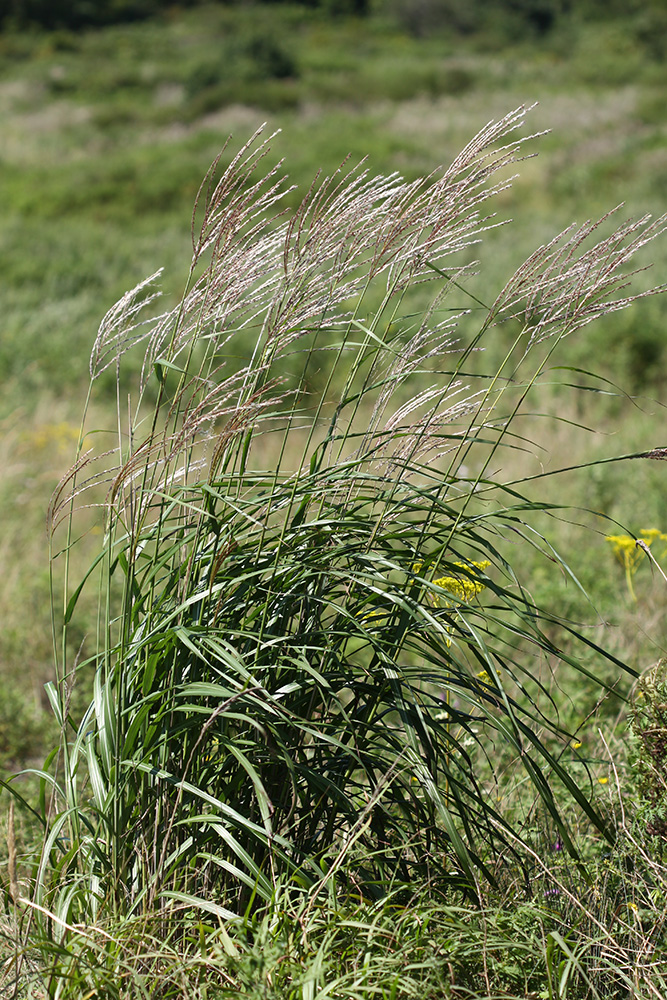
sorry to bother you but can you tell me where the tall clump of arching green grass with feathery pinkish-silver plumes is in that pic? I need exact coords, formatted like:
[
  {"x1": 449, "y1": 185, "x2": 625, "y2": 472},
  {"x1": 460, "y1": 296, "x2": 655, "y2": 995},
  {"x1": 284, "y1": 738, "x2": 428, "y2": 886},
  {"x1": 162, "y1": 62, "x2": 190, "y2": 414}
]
[{"x1": 6, "y1": 109, "x2": 665, "y2": 992}]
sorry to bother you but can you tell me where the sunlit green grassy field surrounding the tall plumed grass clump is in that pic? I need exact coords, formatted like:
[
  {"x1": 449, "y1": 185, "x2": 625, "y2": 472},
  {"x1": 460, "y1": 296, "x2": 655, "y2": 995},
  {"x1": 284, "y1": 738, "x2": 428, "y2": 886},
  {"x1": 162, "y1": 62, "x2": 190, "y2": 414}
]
[{"x1": 0, "y1": 5, "x2": 667, "y2": 1000}]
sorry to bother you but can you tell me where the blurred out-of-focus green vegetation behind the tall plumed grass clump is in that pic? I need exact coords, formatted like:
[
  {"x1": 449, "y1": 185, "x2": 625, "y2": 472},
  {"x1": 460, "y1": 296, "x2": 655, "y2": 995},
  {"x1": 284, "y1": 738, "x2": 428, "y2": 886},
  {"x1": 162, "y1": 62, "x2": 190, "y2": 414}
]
[{"x1": 0, "y1": 0, "x2": 667, "y2": 796}]
